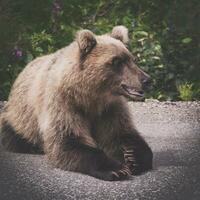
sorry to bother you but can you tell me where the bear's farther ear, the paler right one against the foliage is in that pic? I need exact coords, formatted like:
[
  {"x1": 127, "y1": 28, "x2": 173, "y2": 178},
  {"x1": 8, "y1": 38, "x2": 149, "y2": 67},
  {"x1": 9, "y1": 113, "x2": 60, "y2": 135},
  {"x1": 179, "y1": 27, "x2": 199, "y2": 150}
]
[{"x1": 111, "y1": 26, "x2": 129, "y2": 45}]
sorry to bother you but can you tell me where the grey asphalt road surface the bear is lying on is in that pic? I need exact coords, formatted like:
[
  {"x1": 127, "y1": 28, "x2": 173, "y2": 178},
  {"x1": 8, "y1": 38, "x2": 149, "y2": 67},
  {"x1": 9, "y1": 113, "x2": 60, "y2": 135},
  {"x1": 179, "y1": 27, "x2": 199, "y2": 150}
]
[{"x1": 0, "y1": 101, "x2": 200, "y2": 200}]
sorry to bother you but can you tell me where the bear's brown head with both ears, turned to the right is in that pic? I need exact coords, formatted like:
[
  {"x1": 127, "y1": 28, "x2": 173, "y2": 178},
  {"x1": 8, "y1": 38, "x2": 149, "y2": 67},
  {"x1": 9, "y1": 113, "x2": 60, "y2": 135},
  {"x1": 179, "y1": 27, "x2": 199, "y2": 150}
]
[{"x1": 76, "y1": 26, "x2": 149, "y2": 104}]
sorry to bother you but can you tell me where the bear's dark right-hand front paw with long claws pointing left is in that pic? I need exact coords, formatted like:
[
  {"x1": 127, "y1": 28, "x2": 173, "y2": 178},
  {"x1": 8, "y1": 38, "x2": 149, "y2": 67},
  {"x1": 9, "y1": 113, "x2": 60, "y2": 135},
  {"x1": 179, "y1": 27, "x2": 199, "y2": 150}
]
[{"x1": 121, "y1": 133, "x2": 153, "y2": 175}]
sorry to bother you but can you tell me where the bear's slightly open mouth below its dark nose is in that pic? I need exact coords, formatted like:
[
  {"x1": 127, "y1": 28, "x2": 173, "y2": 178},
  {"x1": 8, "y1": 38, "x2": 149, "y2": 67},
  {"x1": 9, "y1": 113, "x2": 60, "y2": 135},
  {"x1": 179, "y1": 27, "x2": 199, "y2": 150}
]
[{"x1": 121, "y1": 84, "x2": 145, "y2": 101}]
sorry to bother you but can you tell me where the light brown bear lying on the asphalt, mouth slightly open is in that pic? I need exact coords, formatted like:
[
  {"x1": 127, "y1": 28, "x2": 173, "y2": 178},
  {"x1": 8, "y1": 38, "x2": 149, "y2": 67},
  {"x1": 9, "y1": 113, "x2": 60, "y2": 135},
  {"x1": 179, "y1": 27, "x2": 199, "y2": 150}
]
[{"x1": 1, "y1": 26, "x2": 153, "y2": 181}]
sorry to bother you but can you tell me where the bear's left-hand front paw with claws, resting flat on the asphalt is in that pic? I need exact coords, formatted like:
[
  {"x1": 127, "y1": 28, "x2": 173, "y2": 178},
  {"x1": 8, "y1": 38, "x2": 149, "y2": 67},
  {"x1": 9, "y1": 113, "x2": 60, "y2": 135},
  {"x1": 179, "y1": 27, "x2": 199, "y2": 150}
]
[{"x1": 112, "y1": 164, "x2": 131, "y2": 181}]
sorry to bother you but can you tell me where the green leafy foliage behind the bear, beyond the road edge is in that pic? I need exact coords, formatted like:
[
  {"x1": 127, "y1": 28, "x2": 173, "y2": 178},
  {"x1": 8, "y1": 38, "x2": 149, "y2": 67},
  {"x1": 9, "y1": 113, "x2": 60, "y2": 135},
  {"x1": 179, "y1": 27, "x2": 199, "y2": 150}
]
[{"x1": 0, "y1": 0, "x2": 200, "y2": 100}]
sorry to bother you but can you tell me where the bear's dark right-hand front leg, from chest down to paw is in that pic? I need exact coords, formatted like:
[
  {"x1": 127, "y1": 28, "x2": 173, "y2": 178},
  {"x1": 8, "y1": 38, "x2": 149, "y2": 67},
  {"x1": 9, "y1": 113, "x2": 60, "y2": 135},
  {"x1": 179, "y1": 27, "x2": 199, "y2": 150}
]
[{"x1": 94, "y1": 103, "x2": 153, "y2": 175}]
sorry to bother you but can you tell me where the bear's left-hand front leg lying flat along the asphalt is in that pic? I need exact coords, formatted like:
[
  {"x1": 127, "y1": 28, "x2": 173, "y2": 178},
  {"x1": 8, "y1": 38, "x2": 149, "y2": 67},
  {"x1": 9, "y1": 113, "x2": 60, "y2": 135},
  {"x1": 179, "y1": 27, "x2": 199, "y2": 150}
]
[{"x1": 45, "y1": 137, "x2": 131, "y2": 181}]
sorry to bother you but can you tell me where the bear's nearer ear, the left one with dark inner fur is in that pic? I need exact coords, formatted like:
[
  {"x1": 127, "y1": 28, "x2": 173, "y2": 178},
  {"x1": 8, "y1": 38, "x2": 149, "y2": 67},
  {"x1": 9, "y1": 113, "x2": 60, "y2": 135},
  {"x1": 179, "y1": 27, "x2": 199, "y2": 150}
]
[{"x1": 76, "y1": 30, "x2": 97, "y2": 58}]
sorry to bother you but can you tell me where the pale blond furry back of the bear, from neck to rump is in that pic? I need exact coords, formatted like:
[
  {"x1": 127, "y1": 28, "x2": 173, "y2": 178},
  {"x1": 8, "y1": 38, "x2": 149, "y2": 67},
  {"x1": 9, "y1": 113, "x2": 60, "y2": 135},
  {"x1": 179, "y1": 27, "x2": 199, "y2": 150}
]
[{"x1": 3, "y1": 43, "x2": 76, "y2": 143}]
